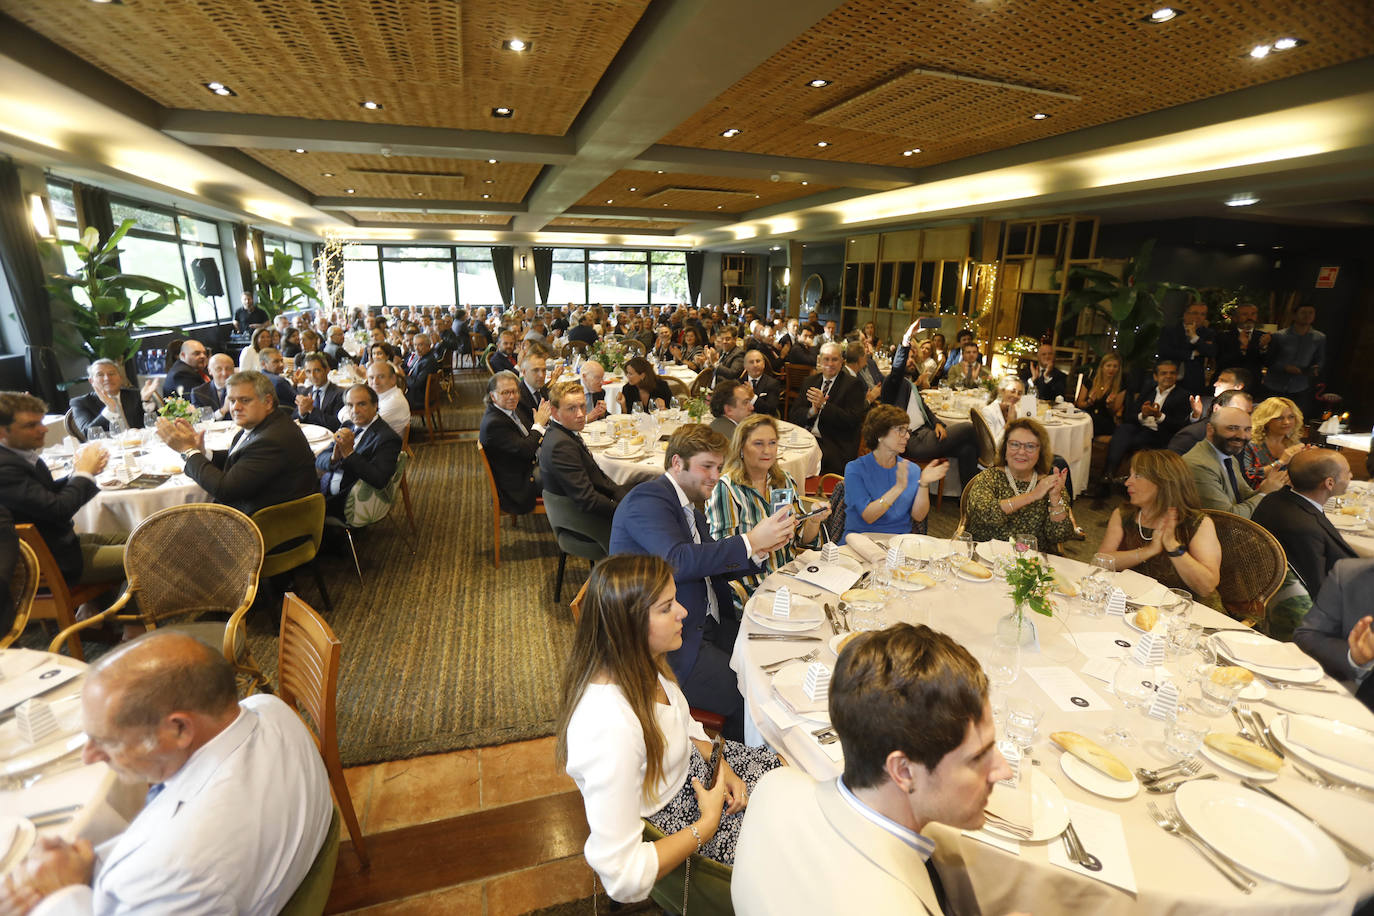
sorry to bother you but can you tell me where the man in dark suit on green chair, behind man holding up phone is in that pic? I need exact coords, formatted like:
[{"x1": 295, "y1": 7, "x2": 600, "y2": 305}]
[{"x1": 539, "y1": 380, "x2": 629, "y2": 553}]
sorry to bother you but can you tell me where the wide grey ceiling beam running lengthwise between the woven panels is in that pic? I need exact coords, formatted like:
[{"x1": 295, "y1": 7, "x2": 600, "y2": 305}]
[{"x1": 513, "y1": 0, "x2": 842, "y2": 231}]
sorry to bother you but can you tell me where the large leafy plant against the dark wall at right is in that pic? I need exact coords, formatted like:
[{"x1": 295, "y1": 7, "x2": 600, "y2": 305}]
[{"x1": 1063, "y1": 239, "x2": 1197, "y2": 368}]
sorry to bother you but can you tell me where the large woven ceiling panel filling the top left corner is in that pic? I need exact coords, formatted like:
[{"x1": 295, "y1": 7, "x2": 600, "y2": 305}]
[{"x1": 0, "y1": 0, "x2": 649, "y2": 135}]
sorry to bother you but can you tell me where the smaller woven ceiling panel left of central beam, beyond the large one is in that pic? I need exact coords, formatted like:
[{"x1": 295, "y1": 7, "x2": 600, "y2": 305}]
[{"x1": 245, "y1": 150, "x2": 541, "y2": 203}]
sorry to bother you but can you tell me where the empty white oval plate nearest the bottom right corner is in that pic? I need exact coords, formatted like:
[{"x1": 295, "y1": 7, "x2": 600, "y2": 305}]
[{"x1": 1173, "y1": 780, "x2": 1351, "y2": 894}]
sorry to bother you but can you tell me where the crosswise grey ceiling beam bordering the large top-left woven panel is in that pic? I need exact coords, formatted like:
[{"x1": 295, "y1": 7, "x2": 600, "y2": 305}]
[{"x1": 158, "y1": 108, "x2": 574, "y2": 163}]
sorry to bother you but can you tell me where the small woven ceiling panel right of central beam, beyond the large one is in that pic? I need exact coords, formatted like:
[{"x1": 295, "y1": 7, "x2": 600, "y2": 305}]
[{"x1": 577, "y1": 170, "x2": 830, "y2": 213}]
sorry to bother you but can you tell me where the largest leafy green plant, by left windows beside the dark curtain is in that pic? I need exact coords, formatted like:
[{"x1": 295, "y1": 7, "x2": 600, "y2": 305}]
[{"x1": 45, "y1": 220, "x2": 185, "y2": 365}]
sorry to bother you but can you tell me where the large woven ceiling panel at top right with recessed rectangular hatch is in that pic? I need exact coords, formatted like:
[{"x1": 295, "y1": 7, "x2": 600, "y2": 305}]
[{"x1": 662, "y1": 0, "x2": 1374, "y2": 166}]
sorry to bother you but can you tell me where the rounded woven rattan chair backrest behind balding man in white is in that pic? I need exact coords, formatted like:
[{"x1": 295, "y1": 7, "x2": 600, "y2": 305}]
[{"x1": 124, "y1": 503, "x2": 264, "y2": 623}]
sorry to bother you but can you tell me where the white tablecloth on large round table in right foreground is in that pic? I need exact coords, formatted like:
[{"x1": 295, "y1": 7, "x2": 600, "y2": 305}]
[{"x1": 731, "y1": 538, "x2": 1374, "y2": 916}]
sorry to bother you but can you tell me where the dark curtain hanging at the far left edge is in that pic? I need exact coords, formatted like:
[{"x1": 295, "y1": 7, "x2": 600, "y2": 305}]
[{"x1": 0, "y1": 161, "x2": 66, "y2": 403}]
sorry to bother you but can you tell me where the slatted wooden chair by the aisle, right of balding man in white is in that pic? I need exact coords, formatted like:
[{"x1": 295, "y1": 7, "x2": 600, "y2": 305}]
[{"x1": 276, "y1": 592, "x2": 368, "y2": 868}]
